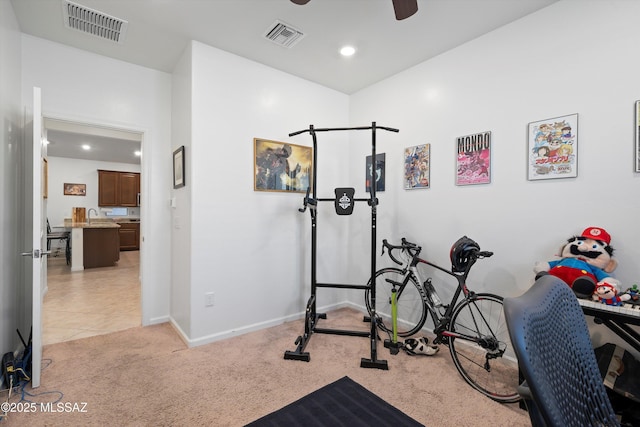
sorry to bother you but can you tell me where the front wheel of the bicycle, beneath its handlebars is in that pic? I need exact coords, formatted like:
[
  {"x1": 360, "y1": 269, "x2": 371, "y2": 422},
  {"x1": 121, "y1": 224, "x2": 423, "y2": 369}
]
[{"x1": 364, "y1": 267, "x2": 427, "y2": 337}]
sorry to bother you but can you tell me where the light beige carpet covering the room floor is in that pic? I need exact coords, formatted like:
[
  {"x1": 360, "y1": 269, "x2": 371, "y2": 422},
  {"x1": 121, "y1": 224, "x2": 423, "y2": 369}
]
[{"x1": 0, "y1": 309, "x2": 530, "y2": 427}]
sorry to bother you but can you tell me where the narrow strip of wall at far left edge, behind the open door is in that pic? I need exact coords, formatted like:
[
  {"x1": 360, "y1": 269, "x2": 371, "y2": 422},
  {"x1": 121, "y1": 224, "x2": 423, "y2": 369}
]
[{"x1": 0, "y1": 0, "x2": 23, "y2": 362}]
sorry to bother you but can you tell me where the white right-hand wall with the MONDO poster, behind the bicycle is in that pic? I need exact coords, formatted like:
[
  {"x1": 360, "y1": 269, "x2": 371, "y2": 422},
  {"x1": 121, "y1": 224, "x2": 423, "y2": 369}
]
[{"x1": 350, "y1": 0, "x2": 640, "y2": 354}]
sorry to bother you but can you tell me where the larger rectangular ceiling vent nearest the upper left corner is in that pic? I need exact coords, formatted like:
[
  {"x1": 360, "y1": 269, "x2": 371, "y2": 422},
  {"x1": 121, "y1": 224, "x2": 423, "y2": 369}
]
[{"x1": 62, "y1": 0, "x2": 129, "y2": 44}]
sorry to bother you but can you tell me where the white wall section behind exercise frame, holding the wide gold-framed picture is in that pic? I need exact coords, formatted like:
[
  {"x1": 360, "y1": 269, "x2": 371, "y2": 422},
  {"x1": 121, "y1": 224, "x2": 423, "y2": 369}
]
[{"x1": 179, "y1": 42, "x2": 349, "y2": 351}]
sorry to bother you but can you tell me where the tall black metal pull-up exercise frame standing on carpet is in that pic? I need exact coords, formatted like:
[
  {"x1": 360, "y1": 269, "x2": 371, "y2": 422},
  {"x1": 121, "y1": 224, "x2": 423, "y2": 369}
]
[{"x1": 284, "y1": 122, "x2": 398, "y2": 370}]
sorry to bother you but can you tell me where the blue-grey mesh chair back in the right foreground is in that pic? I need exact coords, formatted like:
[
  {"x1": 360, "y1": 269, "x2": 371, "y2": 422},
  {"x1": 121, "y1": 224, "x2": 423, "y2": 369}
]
[{"x1": 504, "y1": 275, "x2": 619, "y2": 427}]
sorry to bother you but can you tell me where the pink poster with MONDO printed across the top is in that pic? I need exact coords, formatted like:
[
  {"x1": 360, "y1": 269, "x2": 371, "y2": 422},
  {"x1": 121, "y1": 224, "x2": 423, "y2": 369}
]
[{"x1": 456, "y1": 132, "x2": 491, "y2": 185}]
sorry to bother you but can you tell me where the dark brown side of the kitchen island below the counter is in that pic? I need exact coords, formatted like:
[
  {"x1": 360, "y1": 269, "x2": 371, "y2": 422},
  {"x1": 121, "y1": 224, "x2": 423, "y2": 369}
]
[{"x1": 82, "y1": 228, "x2": 120, "y2": 268}]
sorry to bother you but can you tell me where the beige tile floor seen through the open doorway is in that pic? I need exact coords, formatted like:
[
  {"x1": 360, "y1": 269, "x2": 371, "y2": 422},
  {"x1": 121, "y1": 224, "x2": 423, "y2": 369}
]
[{"x1": 42, "y1": 251, "x2": 142, "y2": 345}]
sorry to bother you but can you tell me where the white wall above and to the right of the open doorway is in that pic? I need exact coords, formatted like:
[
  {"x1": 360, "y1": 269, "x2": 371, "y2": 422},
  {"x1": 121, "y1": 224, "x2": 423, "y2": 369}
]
[{"x1": 22, "y1": 35, "x2": 172, "y2": 324}]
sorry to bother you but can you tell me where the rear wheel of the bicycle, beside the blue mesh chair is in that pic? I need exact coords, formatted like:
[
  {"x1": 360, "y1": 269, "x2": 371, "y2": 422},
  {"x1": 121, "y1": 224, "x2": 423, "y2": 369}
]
[{"x1": 445, "y1": 294, "x2": 520, "y2": 403}]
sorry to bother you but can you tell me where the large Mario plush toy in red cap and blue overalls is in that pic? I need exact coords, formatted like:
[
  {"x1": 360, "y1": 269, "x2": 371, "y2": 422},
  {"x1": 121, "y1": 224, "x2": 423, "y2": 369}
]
[{"x1": 533, "y1": 227, "x2": 619, "y2": 298}]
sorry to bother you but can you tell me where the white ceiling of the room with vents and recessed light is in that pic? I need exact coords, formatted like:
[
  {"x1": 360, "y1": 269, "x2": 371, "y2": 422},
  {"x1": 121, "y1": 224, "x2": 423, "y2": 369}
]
[{"x1": 11, "y1": 0, "x2": 558, "y2": 163}]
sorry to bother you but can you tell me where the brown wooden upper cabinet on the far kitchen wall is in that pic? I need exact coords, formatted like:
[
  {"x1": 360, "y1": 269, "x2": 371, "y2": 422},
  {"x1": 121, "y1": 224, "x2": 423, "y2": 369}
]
[{"x1": 98, "y1": 169, "x2": 140, "y2": 206}]
